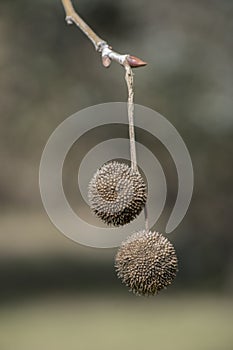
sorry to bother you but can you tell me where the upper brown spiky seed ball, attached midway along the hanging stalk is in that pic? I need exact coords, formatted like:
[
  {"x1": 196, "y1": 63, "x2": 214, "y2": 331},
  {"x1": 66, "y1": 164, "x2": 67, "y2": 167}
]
[{"x1": 88, "y1": 161, "x2": 147, "y2": 226}]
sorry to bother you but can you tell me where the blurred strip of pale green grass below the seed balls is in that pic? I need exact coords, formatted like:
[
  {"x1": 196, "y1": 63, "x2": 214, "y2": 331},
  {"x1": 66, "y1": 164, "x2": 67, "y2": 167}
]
[{"x1": 0, "y1": 294, "x2": 233, "y2": 350}]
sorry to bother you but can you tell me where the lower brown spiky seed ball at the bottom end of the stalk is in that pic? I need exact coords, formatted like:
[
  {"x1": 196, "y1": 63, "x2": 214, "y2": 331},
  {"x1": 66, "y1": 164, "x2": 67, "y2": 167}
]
[{"x1": 115, "y1": 231, "x2": 178, "y2": 296}]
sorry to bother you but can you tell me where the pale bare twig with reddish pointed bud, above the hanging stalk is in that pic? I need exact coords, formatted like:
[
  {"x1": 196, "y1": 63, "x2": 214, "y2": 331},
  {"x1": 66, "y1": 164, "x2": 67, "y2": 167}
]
[{"x1": 61, "y1": 0, "x2": 147, "y2": 68}]
